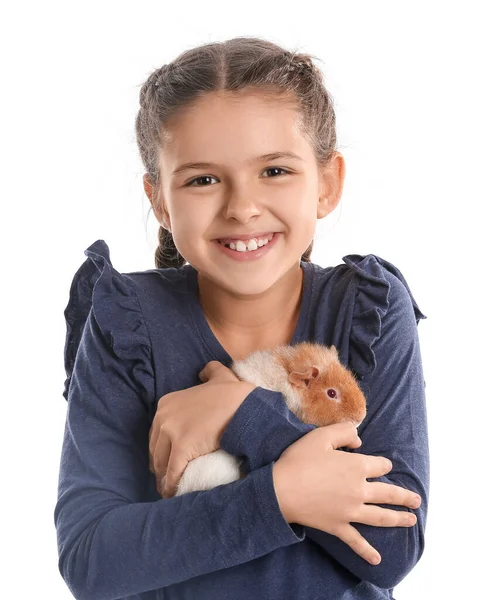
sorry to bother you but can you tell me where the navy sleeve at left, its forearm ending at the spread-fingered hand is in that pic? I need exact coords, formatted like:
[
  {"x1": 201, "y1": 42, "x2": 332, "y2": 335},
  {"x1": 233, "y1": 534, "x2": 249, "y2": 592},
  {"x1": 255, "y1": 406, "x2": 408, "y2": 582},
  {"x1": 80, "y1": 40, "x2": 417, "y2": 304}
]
[{"x1": 54, "y1": 307, "x2": 305, "y2": 600}]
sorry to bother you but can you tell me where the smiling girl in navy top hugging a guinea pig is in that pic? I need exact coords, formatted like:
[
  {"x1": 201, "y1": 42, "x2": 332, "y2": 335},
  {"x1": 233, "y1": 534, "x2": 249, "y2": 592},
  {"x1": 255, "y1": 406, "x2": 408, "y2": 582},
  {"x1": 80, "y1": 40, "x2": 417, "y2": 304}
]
[{"x1": 54, "y1": 38, "x2": 429, "y2": 600}]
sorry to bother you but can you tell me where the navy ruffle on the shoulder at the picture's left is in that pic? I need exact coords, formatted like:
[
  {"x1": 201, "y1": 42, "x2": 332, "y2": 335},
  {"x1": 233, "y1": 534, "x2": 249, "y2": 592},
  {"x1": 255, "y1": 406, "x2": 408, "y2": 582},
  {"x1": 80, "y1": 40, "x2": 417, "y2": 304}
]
[{"x1": 63, "y1": 240, "x2": 152, "y2": 400}]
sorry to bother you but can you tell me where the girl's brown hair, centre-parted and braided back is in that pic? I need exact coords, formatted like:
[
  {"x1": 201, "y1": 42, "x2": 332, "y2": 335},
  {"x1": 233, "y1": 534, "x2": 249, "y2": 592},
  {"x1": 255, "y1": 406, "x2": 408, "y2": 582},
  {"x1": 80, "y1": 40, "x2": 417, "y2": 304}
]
[{"x1": 135, "y1": 37, "x2": 336, "y2": 269}]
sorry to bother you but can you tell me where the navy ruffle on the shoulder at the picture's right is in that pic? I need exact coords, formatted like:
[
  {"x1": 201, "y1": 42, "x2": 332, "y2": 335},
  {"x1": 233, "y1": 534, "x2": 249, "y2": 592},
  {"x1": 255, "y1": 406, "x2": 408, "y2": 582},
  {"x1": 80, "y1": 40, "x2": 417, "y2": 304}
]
[{"x1": 343, "y1": 254, "x2": 427, "y2": 377}]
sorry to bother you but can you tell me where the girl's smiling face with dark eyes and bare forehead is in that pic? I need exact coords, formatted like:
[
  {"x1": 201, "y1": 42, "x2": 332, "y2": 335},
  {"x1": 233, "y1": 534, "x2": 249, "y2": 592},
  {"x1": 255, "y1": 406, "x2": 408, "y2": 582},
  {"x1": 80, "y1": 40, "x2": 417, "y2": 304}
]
[{"x1": 150, "y1": 92, "x2": 344, "y2": 296}]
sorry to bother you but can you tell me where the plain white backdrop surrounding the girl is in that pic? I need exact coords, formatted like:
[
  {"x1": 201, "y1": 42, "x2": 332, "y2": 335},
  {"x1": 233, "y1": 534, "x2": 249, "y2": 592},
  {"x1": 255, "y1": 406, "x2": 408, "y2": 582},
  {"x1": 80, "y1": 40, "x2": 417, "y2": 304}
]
[{"x1": 0, "y1": 0, "x2": 486, "y2": 600}]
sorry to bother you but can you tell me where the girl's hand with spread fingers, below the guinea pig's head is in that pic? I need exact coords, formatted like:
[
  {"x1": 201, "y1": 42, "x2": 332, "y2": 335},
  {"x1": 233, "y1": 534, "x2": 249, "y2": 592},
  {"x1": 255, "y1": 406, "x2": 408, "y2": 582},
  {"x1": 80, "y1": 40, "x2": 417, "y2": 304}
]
[{"x1": 273, "y1": 422, "x2": 421, "y2": 564}]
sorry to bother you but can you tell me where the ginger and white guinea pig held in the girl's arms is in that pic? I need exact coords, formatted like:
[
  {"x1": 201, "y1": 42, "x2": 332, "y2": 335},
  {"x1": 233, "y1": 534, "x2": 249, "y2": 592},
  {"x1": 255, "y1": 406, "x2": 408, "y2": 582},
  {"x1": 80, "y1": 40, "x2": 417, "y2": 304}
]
[{"x1": 167, "y1": 342, "x2": 366, "y2": 496}]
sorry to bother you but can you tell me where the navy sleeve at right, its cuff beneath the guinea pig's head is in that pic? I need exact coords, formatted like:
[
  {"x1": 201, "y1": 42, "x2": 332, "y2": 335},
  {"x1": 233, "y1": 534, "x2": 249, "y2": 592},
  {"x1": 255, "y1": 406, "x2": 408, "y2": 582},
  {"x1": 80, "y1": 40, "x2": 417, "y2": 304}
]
[{"x1": 221, "y1": 272, "x2": 429, "y2": 588}]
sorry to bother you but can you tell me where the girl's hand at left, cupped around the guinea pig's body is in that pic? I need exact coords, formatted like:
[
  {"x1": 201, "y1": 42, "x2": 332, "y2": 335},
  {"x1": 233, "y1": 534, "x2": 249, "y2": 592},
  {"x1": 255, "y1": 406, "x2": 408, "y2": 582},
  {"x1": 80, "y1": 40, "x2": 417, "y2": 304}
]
[{"x1": 149, "y1": 360, "x2": 256, "y2": 498}]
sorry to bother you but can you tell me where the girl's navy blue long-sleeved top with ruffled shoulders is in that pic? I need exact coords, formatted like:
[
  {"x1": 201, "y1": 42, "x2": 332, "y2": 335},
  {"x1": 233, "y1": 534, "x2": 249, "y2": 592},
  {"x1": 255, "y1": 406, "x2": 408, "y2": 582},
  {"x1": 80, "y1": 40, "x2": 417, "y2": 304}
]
[{"x1": 54, "y1": 240, "x2": 429, "y2": 600}]
